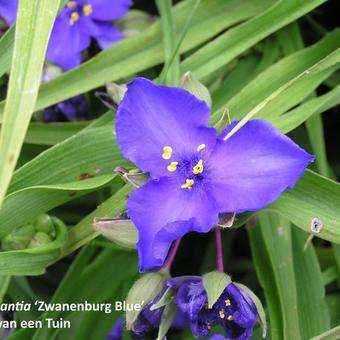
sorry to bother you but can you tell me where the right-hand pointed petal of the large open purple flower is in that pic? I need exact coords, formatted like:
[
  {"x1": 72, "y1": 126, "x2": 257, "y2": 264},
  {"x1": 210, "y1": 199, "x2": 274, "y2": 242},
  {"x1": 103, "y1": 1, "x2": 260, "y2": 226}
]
[{"x1": 207, "y1": 120, "x2": 314, "y2": 212}]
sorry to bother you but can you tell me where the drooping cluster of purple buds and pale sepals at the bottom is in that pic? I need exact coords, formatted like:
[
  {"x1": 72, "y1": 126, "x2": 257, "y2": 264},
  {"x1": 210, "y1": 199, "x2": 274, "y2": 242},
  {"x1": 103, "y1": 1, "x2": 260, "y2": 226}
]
[{"x1": 108, "y1": 271, "x2": 266, "y2": 340}]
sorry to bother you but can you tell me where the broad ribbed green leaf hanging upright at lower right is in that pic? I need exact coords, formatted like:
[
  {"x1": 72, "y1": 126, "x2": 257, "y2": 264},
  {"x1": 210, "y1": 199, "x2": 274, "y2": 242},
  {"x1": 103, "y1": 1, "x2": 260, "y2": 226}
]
[{"x1": 249, "y1": 212, "x2": 329, "y2": 339}]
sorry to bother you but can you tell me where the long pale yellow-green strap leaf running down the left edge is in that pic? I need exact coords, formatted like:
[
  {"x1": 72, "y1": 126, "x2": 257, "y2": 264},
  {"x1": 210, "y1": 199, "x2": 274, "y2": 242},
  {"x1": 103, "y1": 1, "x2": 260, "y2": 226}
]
[{"x1": 0, "y1": 0, "x2": 60, "y2": 206}]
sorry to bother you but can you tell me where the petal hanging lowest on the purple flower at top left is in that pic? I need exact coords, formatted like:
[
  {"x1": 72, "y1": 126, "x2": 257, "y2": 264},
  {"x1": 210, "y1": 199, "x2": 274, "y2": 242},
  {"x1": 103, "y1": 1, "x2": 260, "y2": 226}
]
[{"x1": 47, "y1": 13, "x2": 90, "y2": 71}]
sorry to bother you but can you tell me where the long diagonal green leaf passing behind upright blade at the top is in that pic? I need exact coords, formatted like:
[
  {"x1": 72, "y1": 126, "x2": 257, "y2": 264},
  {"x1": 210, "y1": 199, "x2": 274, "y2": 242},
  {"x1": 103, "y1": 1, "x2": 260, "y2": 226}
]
[{"x1": 0, "y1": 0, "x2": 273, "y2": 116}]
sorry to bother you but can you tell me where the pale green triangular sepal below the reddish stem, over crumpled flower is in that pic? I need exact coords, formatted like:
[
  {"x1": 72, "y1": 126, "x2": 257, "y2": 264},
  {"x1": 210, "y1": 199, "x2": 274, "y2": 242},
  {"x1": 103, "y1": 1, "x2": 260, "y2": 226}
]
[{"x1": 203, "y1": 271, "x2": 231, "y2": 308}]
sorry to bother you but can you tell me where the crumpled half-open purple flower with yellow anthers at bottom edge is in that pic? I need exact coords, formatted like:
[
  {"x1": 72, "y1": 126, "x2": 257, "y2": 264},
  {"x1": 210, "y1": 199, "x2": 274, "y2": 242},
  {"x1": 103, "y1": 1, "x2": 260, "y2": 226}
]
[{"x1": 168, "y1": 277, "x2": 258, "y2": 340}]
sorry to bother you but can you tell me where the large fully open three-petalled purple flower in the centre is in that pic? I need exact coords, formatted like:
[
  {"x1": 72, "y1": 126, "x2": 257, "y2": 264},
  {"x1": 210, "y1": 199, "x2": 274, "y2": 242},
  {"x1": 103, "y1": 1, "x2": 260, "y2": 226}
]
[{"x1": 116, "y1": 78, "x2": 314, "y2": 271}]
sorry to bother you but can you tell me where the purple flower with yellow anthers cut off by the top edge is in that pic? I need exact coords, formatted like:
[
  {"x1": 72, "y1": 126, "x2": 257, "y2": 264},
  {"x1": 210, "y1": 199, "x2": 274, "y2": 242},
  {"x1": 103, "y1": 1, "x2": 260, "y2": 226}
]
[{"x1": 47, "y1": 0, "x2": 132, "y2": 71}]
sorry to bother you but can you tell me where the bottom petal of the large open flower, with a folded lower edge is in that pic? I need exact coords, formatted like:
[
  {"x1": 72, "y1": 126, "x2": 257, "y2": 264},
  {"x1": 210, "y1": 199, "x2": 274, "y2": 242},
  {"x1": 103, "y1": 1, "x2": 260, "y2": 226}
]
[{"x1": 127, "y1": 178, "x2": 218, "y2": 271}]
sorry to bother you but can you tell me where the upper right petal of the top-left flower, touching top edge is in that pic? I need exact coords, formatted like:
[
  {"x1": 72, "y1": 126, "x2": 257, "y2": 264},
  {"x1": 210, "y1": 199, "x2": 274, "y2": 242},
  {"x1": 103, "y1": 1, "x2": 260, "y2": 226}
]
[{"x1": 84, "y1": 0, "x2": 132, "y2": 21}]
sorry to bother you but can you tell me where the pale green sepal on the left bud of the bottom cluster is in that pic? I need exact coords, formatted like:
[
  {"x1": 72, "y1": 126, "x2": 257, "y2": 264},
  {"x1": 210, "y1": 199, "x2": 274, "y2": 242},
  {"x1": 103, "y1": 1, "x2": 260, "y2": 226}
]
[{"x1": 126, "y1": 271, "x2": 168, "y2": 330}]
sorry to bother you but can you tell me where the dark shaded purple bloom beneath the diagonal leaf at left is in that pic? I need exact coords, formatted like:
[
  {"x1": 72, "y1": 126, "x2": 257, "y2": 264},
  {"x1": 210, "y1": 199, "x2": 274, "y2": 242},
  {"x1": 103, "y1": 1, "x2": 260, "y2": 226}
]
[{"x1": 44, "y1": 95, "x2": 88, "y2": 123}]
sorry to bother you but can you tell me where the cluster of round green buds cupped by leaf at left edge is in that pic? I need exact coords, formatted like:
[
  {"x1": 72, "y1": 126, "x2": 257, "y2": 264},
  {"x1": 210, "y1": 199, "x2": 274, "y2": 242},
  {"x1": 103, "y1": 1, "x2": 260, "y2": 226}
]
[{"x1": 1, "y1": 214, "x2": 56, "y2": 251}]
